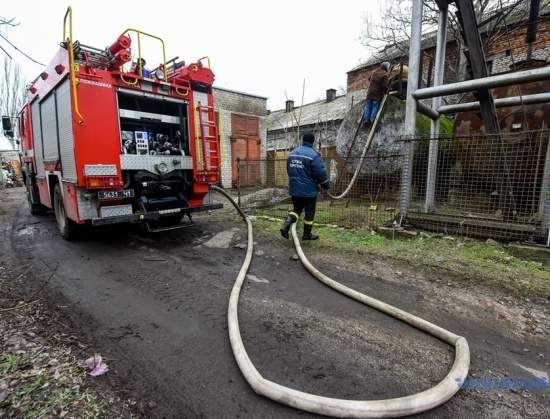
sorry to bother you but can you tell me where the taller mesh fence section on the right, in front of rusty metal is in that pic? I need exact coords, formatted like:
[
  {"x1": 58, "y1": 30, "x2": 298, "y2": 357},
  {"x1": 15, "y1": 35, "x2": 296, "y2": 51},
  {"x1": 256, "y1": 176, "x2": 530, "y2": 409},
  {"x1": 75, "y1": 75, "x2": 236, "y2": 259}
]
[{"x1": 407, "y1": 131, "x2": 550, "y2": 243}]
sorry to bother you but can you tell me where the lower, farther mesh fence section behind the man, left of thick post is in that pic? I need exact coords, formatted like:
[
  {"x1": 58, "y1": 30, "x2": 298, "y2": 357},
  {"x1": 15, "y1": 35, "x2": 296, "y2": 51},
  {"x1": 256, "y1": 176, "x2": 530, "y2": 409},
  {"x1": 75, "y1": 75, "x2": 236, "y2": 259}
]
[{"x1": 235, "y1": 155, "x2": 401, "y2": 228}]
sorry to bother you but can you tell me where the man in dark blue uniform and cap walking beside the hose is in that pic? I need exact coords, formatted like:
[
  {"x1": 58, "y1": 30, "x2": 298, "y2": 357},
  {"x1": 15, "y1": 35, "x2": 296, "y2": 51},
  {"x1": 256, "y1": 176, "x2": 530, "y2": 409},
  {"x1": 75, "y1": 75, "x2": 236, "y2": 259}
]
[{"x1": 281, "y1": 132, "x2": 330, "y2": 240}]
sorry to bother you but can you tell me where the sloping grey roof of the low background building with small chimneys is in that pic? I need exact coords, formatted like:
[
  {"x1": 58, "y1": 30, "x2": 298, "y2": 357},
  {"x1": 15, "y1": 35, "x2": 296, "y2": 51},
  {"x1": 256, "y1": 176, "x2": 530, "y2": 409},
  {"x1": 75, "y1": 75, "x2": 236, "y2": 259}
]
[{"x1": 266, "y1": 95, "x2": 346, "y2": 131}]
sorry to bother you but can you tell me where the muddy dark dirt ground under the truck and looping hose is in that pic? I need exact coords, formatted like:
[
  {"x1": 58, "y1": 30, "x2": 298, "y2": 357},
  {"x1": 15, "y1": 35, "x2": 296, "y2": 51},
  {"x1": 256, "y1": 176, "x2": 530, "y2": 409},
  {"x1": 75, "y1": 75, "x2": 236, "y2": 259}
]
[{"x1": 0, "y1": 189, "x2": 550, "y2": 418}]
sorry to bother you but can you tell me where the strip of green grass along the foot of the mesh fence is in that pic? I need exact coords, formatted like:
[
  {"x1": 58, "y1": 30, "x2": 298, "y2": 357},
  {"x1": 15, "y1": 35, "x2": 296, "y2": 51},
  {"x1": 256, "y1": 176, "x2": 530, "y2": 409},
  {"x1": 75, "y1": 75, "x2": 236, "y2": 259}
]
[{"x1": 254, "y1": 218, "x2": 550, "y2": 299}]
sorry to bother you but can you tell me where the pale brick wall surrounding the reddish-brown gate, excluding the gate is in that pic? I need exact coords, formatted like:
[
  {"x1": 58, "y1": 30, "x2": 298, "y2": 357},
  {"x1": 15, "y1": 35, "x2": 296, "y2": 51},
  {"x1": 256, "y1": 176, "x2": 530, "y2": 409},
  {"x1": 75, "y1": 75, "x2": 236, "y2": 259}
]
[{"x1": 213, "y1": 87, "x2": 267, "y2": 188}]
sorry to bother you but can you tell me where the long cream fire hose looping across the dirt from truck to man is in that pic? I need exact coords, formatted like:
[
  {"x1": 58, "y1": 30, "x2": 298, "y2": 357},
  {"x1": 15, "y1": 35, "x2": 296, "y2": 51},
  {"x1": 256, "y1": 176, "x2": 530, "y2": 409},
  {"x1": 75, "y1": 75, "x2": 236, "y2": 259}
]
[{"x1": 211, "y1": 186, "x2": 470, "y2": 418}]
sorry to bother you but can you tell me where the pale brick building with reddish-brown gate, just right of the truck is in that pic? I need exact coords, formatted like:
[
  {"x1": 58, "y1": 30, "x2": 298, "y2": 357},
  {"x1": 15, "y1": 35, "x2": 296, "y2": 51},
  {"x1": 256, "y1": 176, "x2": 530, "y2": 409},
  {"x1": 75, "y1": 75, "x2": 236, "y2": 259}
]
[{"x1": 213, "y1": 87, "x2": 267, "y2": 188}]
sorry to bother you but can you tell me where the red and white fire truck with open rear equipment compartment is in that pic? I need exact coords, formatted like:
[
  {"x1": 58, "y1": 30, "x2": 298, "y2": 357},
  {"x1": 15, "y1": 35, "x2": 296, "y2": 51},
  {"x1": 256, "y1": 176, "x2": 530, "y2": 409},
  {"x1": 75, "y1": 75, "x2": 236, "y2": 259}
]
[{"x1": 19, "y1": 8, "x2": 221, "y2": 239}]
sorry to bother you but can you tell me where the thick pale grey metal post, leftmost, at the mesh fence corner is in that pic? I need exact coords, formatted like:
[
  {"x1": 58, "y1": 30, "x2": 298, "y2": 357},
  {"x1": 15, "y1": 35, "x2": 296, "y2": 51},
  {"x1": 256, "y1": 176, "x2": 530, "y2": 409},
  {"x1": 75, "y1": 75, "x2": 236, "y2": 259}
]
[{"x1": 399, "y1": 0, "x2": 423, "y2": 221}]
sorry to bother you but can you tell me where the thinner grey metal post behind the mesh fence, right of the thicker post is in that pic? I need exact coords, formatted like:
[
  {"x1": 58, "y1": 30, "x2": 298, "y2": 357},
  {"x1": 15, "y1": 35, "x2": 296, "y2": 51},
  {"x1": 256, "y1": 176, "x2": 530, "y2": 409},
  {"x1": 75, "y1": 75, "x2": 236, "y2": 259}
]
[{"x1": 424, "y1": 4, "x2": 448, "y2": 212}]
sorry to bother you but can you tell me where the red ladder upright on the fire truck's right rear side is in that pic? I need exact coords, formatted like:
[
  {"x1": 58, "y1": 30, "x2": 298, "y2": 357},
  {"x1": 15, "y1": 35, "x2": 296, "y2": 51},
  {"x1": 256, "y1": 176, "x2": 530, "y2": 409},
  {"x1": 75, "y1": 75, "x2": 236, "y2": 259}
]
[{"x1": 195, "y1": 102, "x2": 220, "y2": 182}]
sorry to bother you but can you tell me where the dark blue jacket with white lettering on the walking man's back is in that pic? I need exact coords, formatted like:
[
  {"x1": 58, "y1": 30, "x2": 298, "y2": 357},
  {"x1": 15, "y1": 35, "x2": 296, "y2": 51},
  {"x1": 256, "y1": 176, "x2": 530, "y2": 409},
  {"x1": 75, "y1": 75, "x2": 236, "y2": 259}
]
[{"x1": 286, "y1": 143, "x2": 329, "y2": 198}]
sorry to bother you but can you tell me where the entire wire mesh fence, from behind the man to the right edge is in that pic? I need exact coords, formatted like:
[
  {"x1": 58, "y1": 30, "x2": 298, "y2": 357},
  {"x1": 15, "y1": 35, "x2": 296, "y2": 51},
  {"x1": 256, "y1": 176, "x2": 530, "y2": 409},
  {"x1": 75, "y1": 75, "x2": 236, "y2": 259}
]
[{"x1": 233, "y1": 130, "x2": 550, "y2": 241}]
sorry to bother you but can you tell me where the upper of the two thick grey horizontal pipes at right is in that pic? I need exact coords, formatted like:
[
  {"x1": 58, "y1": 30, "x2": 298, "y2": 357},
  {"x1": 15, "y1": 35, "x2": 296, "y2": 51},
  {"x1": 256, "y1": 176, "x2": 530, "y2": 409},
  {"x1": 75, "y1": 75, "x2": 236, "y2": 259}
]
[{"x1": 409, "y1": 67, "x2": 550, "y2": 99}]
